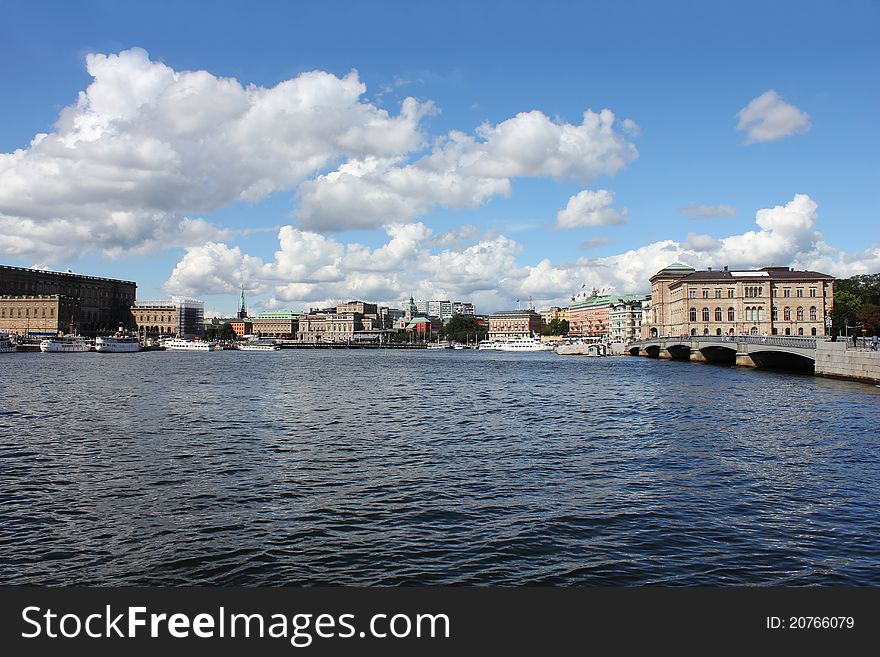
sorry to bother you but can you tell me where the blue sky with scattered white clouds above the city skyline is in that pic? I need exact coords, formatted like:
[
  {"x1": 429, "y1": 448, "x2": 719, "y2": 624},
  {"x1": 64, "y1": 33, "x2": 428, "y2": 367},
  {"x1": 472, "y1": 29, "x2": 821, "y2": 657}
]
[{"x1": 0, "y1": 0, "x2": 880, "y2": 315}]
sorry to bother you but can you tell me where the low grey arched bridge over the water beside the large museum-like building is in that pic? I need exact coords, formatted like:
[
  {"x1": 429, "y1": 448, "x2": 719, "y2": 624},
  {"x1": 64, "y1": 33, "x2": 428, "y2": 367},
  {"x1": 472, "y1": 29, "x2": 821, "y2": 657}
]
[{"x1": 626, "y1": 335, "x2": 824, "y2": 371}]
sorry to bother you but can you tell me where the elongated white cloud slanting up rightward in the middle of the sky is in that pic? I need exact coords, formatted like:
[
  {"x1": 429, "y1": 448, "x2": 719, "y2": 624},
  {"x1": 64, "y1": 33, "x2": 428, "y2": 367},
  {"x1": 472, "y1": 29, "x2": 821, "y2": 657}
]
[{"x1": 296, "y1": 109, "x2": 638, "y2": 231}]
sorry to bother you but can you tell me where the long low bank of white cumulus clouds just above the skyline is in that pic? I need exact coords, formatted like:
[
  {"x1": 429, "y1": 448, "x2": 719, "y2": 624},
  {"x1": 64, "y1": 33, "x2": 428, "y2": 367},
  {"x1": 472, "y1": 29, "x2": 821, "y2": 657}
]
[{"x1": 166, "y1": 194, "x2": 880, "y2": 312}]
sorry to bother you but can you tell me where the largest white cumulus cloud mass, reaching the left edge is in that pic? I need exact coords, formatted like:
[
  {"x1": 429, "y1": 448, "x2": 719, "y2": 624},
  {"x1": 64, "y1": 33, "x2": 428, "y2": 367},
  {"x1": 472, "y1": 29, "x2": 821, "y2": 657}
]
[{"x1": 0, "y1": 48, "x2": 432, "y2": 260}]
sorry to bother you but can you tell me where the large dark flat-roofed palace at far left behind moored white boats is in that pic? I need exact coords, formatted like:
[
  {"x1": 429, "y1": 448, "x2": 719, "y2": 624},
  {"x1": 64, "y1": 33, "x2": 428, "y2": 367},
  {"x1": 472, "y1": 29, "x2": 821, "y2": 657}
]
[{"x1": 0, "y1": 265, "x2": 137, "y2": 335}]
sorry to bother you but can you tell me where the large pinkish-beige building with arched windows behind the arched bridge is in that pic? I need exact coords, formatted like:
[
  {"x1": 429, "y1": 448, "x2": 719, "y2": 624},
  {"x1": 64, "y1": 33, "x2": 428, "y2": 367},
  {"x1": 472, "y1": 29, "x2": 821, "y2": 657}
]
[{"x1": 642, "y1": 263, "x2": 834, "y2": 338}]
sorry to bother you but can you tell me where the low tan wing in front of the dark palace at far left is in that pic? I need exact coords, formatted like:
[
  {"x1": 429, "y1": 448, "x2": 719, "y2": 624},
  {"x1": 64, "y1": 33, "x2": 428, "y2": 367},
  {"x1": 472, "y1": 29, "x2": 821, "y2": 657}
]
[{"x1": 0, "y1": 294, "x2": 80, "y2": 337}]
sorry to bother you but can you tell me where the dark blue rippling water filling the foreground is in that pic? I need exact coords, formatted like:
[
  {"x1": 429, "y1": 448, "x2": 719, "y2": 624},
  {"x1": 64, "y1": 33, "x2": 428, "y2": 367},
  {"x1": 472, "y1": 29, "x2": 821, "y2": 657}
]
[{"x1": 0, "y1": 350, "x2": 880, "y2": 586}]
